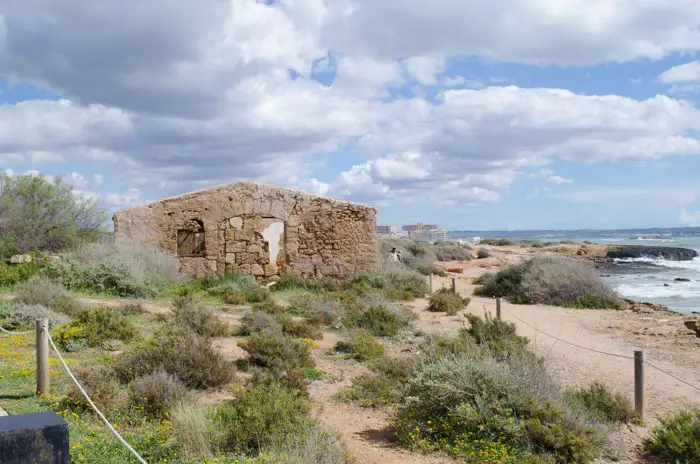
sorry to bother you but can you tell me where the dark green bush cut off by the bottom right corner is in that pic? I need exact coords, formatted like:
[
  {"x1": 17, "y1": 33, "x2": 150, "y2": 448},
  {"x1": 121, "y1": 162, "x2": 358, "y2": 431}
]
[{"x1": 642, "y1": 409, "x2": 700, "y2": 464}]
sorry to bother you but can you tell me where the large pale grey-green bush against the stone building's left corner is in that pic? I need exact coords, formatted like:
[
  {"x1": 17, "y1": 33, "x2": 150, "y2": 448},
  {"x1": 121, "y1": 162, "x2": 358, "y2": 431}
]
[{"x1": 46, "y1": 242, "x2": 180, "y2": 298}]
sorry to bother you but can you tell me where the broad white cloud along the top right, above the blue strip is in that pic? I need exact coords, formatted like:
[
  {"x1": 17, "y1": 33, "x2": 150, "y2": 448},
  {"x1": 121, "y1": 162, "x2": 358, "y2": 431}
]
[{"x1": 325, "y1": 0, "x2": 700, "y2": 65}]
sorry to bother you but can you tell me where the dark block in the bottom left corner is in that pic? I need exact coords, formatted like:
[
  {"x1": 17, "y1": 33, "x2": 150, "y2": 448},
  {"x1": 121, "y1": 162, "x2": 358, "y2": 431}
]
[{"x1": 0, "y1": 412, "x2": 70, "y2": 464}]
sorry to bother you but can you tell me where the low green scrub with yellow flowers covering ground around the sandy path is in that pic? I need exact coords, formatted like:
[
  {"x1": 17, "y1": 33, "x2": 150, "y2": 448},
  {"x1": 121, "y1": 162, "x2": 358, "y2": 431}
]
[{"x1": 0, "y1": 173, "x2": 700, "y2": 464}]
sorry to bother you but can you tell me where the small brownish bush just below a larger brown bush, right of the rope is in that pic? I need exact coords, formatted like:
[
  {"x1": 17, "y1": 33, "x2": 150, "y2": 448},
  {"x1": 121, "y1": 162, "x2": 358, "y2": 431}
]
[{"x1": 129, "y1": 372, "x2": 196, "y2": 420}]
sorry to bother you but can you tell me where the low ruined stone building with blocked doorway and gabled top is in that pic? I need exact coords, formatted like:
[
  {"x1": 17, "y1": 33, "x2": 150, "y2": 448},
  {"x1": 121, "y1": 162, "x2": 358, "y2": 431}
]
[{"x1": 113, "y1": 182, "x2": 376, "y2": 279}]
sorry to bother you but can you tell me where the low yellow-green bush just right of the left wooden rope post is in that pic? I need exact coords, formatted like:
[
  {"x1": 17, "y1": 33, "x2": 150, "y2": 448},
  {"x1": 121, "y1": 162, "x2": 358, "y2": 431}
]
[{"x1": 53, "y1": 308, "x2": 137, "y2": 351}]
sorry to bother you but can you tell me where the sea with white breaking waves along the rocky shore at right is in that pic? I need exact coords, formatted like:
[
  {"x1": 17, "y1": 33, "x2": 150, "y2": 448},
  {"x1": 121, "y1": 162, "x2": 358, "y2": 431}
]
[{"x1": 450, "y1": 228, "x2": 700, "y2": 313}]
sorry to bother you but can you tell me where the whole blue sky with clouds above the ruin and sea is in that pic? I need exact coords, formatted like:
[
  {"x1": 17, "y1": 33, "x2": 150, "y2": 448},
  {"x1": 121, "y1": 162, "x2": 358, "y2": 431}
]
[{"x1": 0, "y1": 0, "x2": 700, "y2": 230}]
